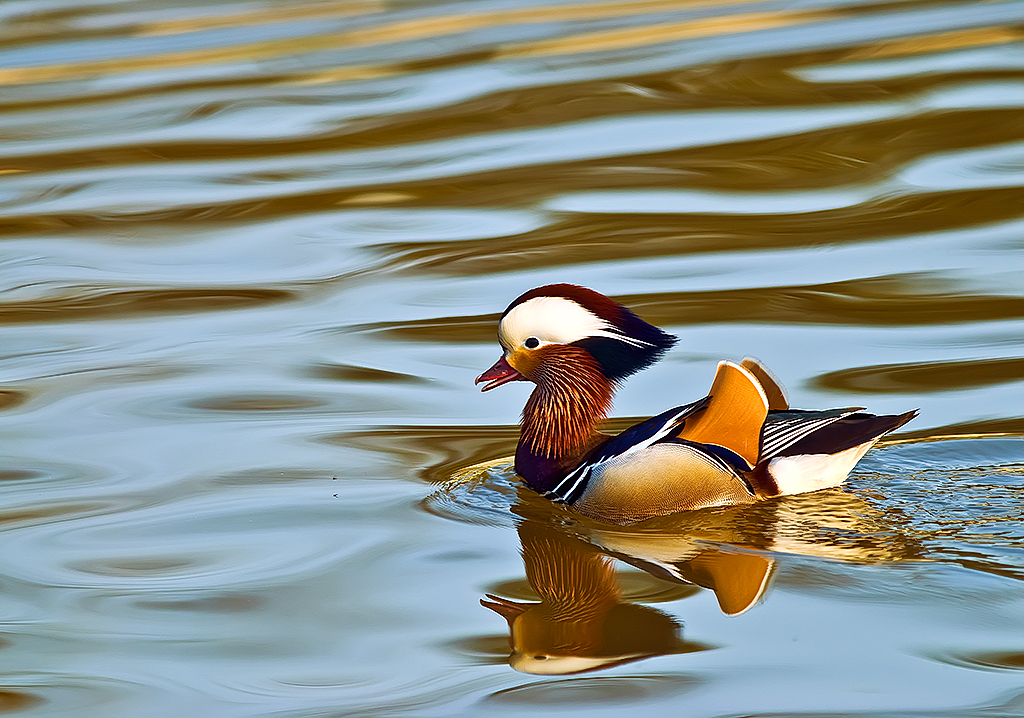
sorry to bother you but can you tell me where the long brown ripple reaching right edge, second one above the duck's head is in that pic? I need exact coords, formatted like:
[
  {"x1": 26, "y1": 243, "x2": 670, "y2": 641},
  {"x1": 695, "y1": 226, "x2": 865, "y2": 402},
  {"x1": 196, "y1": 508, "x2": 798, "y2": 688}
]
[{"x1": 379, "y1": 187, "x2": 1022, "y2": 277}]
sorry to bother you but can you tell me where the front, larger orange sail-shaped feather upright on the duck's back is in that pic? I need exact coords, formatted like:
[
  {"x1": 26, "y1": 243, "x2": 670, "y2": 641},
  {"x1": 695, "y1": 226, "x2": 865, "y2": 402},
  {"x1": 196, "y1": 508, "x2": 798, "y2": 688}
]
[{"x1": 676, "y1": 362, "x2": 765, "y2": 469}]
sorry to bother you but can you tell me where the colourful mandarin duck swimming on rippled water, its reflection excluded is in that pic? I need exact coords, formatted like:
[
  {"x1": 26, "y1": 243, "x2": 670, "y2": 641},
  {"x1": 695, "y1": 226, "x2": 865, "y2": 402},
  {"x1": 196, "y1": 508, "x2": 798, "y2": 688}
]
[{"x1": 475, "y1": 284, "x2": 918, "y2": 525}]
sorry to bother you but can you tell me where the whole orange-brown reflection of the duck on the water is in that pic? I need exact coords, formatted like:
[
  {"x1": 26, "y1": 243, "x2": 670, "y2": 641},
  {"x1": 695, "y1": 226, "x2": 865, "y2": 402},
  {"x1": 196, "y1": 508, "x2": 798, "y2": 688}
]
[{"x1": 480, "y1": 481, "x2": 918, "y2": 674}]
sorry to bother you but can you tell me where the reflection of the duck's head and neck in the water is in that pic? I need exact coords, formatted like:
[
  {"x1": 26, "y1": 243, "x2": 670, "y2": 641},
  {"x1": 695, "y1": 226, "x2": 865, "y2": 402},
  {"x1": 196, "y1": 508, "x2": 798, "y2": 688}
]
[{"x1": 480, "y1": 521, "x2": 708, "y2": 674}]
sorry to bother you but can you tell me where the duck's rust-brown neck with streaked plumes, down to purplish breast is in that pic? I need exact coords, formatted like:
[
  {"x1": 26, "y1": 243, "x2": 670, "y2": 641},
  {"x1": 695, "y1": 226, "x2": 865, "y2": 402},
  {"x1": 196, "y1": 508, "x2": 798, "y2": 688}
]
[{"x1": 516, "y1": 346, "x2": 614, "y2": 491}]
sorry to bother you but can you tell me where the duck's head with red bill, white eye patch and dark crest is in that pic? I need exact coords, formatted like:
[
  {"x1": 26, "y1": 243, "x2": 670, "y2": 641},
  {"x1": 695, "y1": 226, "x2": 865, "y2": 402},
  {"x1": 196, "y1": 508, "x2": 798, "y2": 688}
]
[{"x1": 476, "y1": 284, "x2": 677, "y2": 391}]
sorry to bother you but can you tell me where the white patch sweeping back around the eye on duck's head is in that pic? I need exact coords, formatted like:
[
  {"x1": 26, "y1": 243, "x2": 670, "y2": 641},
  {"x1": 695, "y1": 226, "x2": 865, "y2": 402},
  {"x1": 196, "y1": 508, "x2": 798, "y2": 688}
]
[{"x1": 498, "y1": 297, "x2": 650, "y2": 349}]
